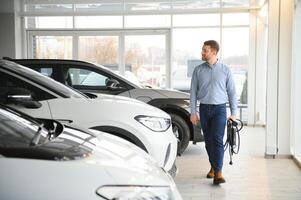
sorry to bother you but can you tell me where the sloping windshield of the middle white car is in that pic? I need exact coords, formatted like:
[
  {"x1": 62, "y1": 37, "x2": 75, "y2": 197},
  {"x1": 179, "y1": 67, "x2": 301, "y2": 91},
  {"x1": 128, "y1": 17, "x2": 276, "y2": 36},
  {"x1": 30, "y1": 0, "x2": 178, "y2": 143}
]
[{"x1": 4, "y1": 61, "x2": 87, "y2": 98}]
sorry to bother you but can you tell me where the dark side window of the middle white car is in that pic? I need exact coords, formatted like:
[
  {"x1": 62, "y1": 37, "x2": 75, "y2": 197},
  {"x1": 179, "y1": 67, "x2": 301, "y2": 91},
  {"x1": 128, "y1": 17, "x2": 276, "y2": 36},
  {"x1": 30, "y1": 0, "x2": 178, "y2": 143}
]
[{"x1": 0, "y1": 71, "x2": 55, "y2": 103}]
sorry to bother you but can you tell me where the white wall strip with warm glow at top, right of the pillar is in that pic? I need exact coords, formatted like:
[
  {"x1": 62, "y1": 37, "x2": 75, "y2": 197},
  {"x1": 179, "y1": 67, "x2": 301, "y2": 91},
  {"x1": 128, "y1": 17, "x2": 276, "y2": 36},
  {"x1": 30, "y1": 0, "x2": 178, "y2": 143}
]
[{"x1": 277, "y1": 0, "x2": 294, "y2": 154}]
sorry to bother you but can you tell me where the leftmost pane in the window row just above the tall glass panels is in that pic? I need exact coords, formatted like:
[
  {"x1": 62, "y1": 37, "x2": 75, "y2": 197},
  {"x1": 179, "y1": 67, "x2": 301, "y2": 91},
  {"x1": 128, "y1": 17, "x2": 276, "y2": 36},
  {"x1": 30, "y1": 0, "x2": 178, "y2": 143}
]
[{"x1": 25, "y1": 16, "x2": 73, "y2": 29}]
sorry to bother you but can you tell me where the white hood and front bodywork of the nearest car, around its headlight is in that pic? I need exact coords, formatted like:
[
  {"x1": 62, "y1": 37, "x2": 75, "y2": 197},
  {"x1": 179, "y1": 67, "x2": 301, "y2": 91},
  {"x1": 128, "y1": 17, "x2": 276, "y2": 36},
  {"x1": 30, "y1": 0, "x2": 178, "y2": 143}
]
[{"x1": 0, "y1": 127, "x2": 176, "y2": 200}]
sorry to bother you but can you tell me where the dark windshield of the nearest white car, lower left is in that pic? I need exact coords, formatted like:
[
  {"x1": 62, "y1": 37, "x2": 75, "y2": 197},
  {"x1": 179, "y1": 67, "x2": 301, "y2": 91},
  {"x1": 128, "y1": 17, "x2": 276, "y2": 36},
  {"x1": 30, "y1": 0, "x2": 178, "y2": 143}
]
[{"x1": 0, "y1": 108, "x2": 48, "y2": 146}]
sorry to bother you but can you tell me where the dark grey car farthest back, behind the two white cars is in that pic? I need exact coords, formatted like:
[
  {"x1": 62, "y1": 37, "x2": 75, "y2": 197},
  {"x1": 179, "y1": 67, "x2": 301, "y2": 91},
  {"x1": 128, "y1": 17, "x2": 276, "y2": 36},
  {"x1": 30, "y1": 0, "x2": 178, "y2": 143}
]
[{"x1": 6, "y1": 58, "x2": 204, "y2": 155}]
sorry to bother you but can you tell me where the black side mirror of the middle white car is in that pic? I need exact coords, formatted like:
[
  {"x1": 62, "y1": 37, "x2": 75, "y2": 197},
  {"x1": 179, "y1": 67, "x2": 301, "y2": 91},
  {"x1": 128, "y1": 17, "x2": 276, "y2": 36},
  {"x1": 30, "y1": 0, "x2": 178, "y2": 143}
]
[{"x1": 6, "y1": 89, "x2": 42, "y2": 108}]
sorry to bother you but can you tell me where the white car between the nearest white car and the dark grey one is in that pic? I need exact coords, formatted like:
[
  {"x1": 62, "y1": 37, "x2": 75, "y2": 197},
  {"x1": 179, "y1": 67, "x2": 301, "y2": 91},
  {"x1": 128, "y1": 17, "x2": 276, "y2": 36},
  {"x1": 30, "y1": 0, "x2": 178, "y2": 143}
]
[{"x1": 0, "y1": 60, "x2": 177, "y2": 173}]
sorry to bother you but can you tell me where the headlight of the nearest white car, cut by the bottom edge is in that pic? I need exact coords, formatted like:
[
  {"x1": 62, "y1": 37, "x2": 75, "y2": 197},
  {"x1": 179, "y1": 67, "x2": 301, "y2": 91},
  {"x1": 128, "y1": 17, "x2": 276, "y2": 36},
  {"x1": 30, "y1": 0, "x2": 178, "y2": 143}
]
[{"x1": 96, "y1": 186, "x2": 172, "y2": 200}]
